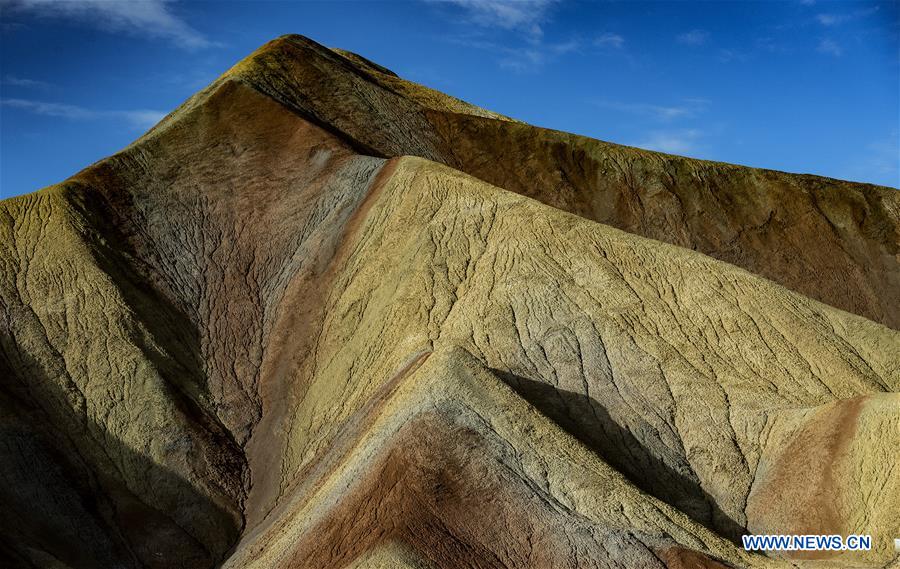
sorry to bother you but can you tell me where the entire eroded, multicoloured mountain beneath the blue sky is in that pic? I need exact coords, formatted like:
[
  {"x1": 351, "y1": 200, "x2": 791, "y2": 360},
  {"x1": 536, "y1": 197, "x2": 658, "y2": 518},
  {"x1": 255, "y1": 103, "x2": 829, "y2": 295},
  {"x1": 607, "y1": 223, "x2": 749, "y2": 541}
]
[{"x1": 0, "y1": 36, "x2": 900, "y2": 569}]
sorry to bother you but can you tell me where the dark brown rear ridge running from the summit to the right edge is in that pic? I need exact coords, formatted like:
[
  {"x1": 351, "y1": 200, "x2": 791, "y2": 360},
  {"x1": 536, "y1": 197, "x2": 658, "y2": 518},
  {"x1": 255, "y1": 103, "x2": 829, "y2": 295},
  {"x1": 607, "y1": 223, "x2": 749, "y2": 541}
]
[{"x1": 186, "y1": 36, "x2": 900, "y2": 328}]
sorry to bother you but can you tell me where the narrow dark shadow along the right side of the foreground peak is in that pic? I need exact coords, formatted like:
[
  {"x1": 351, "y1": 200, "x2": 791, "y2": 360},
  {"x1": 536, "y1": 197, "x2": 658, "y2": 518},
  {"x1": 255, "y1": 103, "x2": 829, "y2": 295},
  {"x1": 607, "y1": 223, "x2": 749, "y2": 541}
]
[{"x1": 492, "y1": 369, "x2": 746, "y2": 543}]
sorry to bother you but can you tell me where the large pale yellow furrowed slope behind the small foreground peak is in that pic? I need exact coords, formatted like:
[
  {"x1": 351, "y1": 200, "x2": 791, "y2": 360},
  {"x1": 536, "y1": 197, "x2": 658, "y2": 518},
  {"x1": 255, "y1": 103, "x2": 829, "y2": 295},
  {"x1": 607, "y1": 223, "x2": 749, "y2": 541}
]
[{"x1": 221, "y1": 154, "x2": 900, "y2": 559}]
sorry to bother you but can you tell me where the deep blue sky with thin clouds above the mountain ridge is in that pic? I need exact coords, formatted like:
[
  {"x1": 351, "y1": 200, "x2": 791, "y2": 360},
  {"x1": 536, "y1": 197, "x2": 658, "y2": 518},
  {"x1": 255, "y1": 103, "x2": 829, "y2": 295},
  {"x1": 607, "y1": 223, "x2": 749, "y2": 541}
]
[{"x1": 0, "y1": 0, "x2": 900, "y2": 197}]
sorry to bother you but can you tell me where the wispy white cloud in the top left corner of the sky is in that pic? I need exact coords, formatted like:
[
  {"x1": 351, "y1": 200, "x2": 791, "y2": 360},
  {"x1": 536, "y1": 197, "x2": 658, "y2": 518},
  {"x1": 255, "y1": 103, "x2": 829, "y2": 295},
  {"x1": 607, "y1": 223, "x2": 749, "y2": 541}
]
[{"x1": 0, "y1": 0, "x2": 214, "y2": 49}]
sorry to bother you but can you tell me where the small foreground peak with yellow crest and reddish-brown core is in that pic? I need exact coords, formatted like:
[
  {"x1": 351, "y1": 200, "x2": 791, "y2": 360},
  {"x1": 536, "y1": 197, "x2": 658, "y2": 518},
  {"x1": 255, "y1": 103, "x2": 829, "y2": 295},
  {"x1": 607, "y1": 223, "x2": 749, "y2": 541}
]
[{"x1": 226, "y1": 347, "x2": 775, "y2": 569}]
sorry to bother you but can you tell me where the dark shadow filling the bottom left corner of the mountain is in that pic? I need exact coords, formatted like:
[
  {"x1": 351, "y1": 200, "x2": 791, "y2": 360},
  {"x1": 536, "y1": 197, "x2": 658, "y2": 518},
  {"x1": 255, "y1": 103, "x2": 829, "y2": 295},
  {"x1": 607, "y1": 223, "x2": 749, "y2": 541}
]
[{"x1": 0, "y1": 346, "x2": 240, "y2": 569}]
